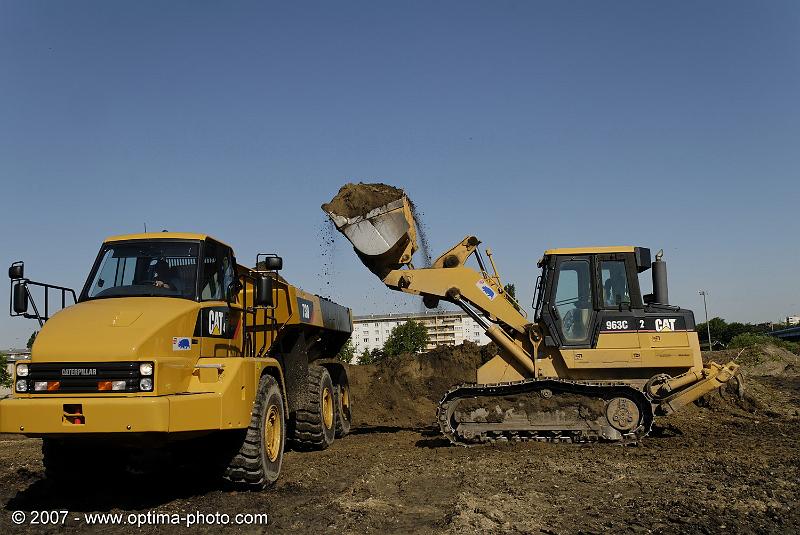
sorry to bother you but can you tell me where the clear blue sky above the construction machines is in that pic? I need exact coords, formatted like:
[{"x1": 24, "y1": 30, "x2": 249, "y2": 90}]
[{"x1": 0, "y1": 1, "x2": 800, "y2": 347}]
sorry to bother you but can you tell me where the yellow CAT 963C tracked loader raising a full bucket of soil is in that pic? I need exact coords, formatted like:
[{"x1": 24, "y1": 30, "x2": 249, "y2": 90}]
[{"x1": 322, "y1": 184, "x2": 742, "y2": 445}]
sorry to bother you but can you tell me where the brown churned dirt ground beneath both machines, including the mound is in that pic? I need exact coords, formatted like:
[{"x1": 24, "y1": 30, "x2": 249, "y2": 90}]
[{"x1": 0, "y1": 346, "x2": 800, "y2": 534}]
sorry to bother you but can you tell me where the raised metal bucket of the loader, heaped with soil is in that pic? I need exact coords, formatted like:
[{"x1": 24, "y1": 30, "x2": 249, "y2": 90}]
[{"x1": 322, "y1": 184, "x2": 417, "y2": 279}]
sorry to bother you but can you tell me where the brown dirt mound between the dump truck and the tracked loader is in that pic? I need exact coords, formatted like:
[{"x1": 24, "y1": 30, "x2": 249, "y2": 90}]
[{"x1": 348, "y1": 342, "x2": 495, "y2": 427}]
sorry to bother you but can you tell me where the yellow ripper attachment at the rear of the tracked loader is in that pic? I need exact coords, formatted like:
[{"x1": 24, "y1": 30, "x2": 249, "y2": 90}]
[{"x1": 645, "y1": 361, "x2": 744, "y2": 416}]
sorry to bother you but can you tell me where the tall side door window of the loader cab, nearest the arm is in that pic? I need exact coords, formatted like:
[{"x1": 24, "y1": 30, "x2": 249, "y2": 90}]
[{"x1": 554, "y1": 259, "x2": 593, "y2": 344}]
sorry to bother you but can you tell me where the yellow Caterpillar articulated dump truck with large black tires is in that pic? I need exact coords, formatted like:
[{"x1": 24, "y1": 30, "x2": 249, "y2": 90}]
[{"x1": 0, "y1": 232, "x2": 352, "y2": 489}]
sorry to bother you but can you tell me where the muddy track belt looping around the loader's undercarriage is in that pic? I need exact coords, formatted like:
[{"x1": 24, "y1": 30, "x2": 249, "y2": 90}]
[{"x1": 437, "y1": 379, "x2": 653, "y2": 446}]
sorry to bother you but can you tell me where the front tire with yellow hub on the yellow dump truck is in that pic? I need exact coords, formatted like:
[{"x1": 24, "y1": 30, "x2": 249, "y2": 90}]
[{"x1": 224, "y1": 375, "x2": 286, "y2": 490}]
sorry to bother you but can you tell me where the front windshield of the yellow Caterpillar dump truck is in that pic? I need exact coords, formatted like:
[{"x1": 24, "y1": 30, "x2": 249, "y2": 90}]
[{"x1": 81, "y1": 240, "x2": 200, "y2": 300}]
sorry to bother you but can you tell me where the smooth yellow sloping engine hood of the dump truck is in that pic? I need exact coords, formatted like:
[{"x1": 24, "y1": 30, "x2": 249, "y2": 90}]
[{"x1": 31, "y1": 297, "x2": 199, "y2": 362}]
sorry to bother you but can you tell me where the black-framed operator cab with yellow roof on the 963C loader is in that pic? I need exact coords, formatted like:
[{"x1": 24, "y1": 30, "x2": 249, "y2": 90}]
[{"x1": 536, "y1": 247, "x2": 650, "y2": 348}]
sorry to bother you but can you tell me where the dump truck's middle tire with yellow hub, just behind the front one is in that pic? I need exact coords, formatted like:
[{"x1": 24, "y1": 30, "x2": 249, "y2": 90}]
[{"x1": 292, "y1": 364, "x2": 336, "y2": 450}]
